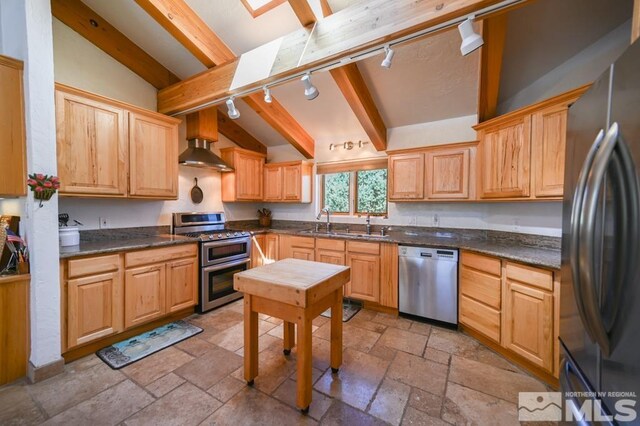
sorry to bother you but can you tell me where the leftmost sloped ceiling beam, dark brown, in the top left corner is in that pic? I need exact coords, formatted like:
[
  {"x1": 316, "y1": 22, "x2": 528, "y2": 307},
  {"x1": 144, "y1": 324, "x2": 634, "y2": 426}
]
[{"x1": 51, "y1": 0, "x2": 180, "y2": 89}]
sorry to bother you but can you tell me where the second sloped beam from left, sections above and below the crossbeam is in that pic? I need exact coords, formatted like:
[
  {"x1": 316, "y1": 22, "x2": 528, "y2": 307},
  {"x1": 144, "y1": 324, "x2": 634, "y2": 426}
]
[{"x1": 136, "y1": 0, "x2": 315, "y2": 158}]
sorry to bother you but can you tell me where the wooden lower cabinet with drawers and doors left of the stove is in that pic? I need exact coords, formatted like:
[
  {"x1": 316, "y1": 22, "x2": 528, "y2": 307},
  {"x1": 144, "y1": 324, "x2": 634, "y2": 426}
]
[{"x1": 61, "y1": 244, "x2": 198, "y2": 352}]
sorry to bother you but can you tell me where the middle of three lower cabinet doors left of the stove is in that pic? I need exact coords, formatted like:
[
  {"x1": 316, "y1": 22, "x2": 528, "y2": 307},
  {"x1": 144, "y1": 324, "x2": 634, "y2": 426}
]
[{"x1": 124, "y1": 264, "x2": 166, "y2": 328}]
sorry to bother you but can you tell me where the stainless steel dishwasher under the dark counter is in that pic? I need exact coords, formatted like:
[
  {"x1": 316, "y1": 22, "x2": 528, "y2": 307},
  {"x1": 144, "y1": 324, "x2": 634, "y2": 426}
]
[{"x1": 398, "y1": 246, "x2": 458, "y2": 324}]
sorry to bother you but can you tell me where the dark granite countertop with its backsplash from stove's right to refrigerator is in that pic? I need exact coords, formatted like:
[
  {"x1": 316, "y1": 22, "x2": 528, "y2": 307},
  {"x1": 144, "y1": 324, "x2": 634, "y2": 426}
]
[{"x1": 228, "y1": 221, "x2": 561, "y2": 270}]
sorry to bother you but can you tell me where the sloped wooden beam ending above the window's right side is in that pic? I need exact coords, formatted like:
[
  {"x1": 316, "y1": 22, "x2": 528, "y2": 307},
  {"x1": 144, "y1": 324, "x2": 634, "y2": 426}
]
[{"x1": 318, "y1": 0, "x2": 387, "y2": 151}]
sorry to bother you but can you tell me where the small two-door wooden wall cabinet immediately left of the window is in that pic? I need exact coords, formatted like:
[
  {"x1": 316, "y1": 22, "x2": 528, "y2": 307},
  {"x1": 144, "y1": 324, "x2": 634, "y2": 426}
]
[{"x1": 264, "y1": 161, "x2": 313, "y2": 203}]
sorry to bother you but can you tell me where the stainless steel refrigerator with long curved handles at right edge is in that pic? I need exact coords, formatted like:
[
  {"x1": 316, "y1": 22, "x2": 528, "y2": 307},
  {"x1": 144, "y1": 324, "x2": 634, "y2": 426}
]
[{"x1": 560, "y1": 39, "x2": 640, "y2": 423}]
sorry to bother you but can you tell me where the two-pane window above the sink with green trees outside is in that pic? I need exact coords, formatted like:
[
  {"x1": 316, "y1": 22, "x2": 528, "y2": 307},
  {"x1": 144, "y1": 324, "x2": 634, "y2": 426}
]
[{"x1": 322, "y1": 169, "x2": 387, "y2": 216}]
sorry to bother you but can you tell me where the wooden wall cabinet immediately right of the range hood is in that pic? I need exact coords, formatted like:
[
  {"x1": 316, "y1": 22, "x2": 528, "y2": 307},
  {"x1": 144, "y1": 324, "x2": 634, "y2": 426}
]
[{"x1": 220, "y1": 148, "x2": 266, "y2": 202}]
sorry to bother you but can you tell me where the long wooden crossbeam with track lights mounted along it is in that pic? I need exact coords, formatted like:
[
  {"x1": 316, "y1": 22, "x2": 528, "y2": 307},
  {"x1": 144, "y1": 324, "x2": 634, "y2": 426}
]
[{"x1": 158, "y1": 0, "x2": 508, "y2": 114}]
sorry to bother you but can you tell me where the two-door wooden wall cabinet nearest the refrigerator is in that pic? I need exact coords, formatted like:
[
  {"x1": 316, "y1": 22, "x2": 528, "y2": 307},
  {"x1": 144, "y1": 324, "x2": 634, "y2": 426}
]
[{"x1": 474, "y1": 85, "x2": 589, "y2": 200}]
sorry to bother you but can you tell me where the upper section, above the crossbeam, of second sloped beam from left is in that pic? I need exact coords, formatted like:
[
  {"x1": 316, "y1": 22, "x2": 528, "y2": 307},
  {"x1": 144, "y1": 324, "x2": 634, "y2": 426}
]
[{"x1": 135, "y1": 0, "x2": 236, "y2": 68}]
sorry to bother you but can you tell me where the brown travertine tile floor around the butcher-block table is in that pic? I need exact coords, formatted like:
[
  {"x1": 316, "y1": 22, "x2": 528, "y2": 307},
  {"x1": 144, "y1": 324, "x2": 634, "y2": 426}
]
[{"x1": 0, "y1": 301, "x2": 546, "y2": 426}]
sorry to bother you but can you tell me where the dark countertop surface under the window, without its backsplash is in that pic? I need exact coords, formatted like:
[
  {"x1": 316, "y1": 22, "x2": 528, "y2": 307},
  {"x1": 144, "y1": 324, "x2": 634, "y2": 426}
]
[{"x1": 239, "y1": 226, "x2": 560, "y2": 271}]
